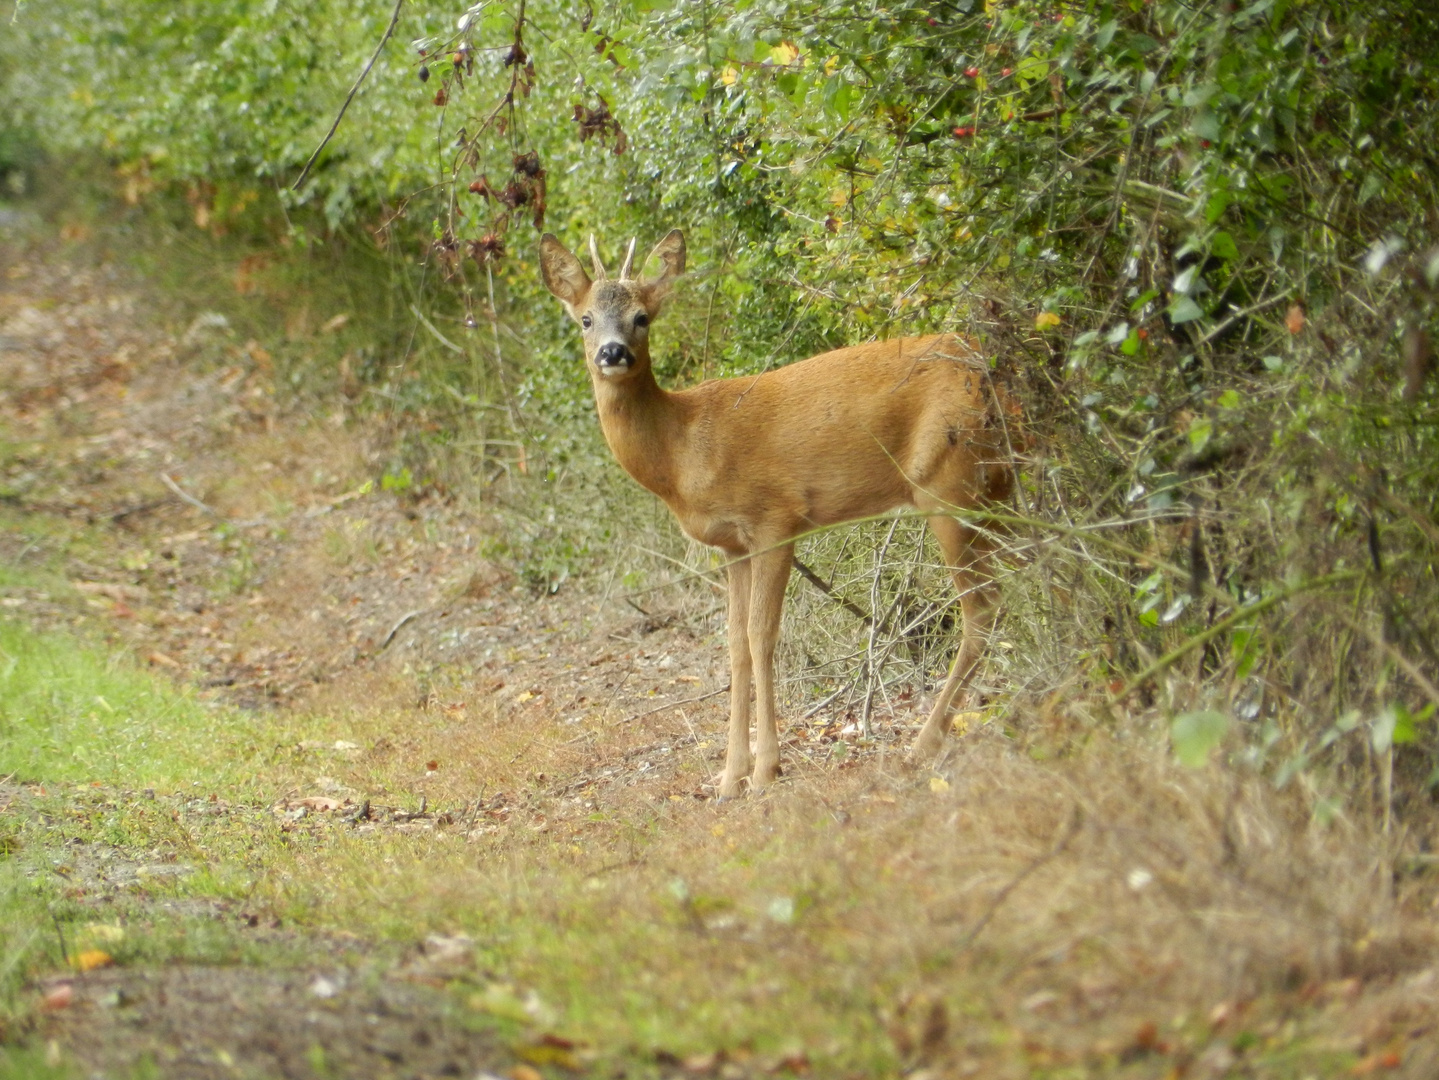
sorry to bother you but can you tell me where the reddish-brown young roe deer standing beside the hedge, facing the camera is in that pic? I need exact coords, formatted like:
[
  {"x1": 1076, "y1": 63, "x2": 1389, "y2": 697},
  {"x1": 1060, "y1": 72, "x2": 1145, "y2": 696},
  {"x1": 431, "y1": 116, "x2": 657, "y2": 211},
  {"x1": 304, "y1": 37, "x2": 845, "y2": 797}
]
[{"x1": 540, "y1": 229, "x2": 1013, "y2": 797}]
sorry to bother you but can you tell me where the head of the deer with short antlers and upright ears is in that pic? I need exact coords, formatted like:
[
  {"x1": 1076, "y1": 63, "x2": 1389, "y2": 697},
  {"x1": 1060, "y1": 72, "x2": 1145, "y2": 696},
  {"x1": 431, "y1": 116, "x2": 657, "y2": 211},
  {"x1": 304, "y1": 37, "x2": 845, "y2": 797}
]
[{"x1": 540, "y1": 229, "x2": 685, "y2": 380}]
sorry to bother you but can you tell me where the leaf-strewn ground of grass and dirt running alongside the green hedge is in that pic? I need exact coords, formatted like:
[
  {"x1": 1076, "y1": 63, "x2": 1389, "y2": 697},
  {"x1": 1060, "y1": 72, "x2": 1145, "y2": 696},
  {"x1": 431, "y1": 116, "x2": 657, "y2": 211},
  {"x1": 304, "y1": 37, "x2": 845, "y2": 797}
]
[{"x1": 0, "y1": 212, "x2": 1439, "y2": 1080}]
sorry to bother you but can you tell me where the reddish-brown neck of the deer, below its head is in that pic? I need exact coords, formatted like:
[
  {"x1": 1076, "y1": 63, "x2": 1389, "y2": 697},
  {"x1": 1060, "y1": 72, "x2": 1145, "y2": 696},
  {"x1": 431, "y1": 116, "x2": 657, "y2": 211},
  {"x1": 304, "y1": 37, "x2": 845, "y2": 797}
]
[{"x1": 591, "y1": 357, "x2": 684, "y2": 502}]
